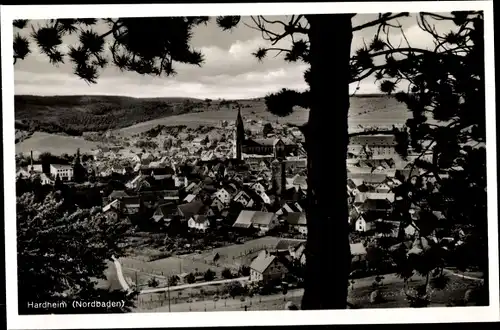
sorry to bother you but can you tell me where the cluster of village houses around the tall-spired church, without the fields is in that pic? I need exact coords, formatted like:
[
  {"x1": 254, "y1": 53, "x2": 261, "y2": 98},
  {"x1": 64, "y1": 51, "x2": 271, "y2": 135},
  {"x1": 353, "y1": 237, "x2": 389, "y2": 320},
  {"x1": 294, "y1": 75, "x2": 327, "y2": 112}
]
[{"x1": 17, "y1": 107, "x2": 454, "y2": 280}]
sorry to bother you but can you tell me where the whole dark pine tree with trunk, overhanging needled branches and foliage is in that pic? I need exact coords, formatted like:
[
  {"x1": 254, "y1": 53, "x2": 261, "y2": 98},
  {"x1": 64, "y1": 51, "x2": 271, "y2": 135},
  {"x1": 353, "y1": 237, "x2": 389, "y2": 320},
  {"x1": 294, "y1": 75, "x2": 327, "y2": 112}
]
[{"x1": 14, "y1": 12, "x2": 487, "y2": 309}]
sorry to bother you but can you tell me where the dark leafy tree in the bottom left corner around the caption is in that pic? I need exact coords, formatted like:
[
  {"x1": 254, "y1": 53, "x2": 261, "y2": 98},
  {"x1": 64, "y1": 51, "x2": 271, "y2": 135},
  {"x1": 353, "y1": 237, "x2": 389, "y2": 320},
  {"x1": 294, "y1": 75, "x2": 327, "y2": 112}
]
[{"x1": 16, "y1": 193, "x2": 135, "y2": 314}]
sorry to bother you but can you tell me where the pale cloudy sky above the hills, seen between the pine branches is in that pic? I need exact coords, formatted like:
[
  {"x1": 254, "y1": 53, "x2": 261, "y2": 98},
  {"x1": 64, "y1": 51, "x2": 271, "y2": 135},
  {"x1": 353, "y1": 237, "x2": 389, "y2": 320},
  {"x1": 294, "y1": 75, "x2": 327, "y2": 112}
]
[{"x1": 14, "y1": 14, "x2": 451, "y2": 99}]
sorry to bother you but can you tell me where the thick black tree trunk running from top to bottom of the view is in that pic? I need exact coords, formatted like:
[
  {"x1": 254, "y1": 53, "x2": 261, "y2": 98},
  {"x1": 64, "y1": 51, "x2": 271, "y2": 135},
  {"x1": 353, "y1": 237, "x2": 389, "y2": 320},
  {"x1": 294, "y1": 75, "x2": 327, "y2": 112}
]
[{"x1": 301, "y1": 14, "x2": 352, "y2": 310}]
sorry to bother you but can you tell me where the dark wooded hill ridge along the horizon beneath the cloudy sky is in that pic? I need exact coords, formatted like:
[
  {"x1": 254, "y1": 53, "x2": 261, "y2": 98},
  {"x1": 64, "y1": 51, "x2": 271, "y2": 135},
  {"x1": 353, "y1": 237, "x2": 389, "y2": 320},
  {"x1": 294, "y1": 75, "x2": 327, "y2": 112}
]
[{"x1": 15, "y1": 95, "x2": 387, "y2": 135}]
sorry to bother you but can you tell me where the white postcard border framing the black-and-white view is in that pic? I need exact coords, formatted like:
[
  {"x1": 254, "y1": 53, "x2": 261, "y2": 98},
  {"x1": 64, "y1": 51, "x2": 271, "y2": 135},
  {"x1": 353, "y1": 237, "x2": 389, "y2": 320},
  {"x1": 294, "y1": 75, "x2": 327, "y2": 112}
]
[{"x1": 1, "y1": 1, "x2": 500, "y2": 329}]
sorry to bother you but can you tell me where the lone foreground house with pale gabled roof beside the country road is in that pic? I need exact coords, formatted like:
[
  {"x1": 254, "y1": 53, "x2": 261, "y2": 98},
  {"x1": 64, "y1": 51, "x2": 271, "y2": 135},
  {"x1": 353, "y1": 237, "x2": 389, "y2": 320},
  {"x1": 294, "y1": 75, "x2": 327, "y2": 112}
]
[{"x1": 250, "y1": 250, "x2": 288, "y2": 283}]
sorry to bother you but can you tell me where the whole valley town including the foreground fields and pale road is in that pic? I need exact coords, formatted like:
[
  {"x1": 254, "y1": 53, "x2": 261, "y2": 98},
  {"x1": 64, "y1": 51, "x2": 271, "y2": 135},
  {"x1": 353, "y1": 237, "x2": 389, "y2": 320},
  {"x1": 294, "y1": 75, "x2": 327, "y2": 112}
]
[{"x1": 16, "y1": 109, "x2": 476, "y2": 311}]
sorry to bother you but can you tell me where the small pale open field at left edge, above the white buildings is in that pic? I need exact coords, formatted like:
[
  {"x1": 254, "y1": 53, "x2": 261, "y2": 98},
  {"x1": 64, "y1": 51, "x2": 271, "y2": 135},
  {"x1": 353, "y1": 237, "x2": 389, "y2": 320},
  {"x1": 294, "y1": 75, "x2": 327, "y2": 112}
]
[{"x1": 16, "y1": 132, "x2": 98, "y2": 157}]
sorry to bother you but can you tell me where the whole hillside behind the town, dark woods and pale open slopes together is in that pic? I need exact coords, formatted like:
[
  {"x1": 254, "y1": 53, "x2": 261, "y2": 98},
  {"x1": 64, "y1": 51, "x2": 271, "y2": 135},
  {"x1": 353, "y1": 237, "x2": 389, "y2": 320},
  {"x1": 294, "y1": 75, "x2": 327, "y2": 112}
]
[{"x1": 15, "y1": 95, "x2": 408, "y2": 136}]
